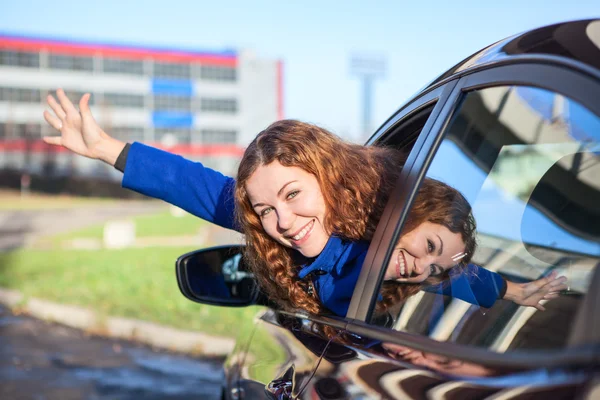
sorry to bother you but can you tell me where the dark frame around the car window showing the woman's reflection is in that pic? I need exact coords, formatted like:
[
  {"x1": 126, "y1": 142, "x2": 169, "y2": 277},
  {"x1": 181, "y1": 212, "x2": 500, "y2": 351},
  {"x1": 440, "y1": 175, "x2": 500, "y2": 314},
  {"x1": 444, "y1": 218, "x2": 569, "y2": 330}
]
[{"x1": 346, "y1": 60, "x2": 600, "y2": 366}]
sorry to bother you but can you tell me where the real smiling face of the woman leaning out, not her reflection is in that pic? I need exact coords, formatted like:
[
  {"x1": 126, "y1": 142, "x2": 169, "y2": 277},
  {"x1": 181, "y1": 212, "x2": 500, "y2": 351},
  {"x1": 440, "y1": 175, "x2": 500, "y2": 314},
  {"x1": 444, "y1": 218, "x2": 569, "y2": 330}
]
[{"x1": 246, "y1": 161, "x2": 329, "y2": 257}]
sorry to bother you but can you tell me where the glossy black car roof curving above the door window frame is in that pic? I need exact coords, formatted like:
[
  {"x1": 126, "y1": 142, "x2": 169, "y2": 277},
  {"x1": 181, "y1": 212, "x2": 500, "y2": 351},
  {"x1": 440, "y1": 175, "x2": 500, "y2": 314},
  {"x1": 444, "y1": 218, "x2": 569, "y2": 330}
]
[{"x1": 423, "y1": 19, "x2": 600, "y2": 91}]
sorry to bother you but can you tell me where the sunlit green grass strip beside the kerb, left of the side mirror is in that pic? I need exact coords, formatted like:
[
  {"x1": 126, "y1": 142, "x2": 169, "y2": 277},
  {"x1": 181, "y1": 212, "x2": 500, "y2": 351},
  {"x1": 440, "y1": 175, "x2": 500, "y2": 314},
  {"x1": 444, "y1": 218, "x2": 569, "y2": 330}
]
[{"x1": 0, "y1": 248, "x2": 256, "y2": 337}]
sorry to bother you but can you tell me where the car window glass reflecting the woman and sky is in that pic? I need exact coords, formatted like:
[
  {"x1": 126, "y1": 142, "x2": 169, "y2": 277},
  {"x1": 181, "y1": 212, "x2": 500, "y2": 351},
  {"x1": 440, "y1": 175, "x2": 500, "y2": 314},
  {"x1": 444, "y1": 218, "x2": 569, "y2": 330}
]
[{"x1": 371, "y1": 86, "x2": 600, "y2": 352}]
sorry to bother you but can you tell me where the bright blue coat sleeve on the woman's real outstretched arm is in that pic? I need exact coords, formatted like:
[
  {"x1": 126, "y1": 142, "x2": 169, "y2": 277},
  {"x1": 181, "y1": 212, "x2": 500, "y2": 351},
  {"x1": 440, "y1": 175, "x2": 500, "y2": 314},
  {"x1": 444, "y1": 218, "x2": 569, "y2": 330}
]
[{"x1": 122, "y1": 143, "x2": 239, "y2": 230}]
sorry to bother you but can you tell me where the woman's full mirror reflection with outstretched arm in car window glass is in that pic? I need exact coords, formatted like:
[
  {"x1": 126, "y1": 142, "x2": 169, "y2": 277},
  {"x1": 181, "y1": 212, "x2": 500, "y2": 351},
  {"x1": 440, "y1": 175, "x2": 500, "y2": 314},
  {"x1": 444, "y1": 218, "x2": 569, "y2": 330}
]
[{"x1": 377, "y1": 178, "x2": 566, "y2": 311}]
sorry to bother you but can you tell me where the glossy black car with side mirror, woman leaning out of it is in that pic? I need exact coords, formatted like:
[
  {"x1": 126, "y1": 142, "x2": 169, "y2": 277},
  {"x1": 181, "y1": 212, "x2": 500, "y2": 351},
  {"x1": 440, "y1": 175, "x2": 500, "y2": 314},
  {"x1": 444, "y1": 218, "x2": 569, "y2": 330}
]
[{"x1": 177, "y1": 20, "x2": 600, "y2": 399}]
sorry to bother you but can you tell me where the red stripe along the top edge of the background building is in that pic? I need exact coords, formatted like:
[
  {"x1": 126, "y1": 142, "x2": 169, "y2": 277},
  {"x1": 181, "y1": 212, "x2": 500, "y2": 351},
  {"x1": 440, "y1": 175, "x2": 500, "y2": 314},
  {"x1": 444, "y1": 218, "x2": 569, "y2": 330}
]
[{"x1": 0, "y1": 37, "x2": 237, "y2": 67}]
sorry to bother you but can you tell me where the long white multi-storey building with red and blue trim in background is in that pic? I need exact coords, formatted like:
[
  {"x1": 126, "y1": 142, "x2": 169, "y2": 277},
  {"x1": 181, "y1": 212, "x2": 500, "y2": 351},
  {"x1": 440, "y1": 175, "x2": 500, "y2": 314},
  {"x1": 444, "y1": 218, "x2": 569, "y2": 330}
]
[{"x1": 0, "y1": 34, "x2": 283, "y2": 179}]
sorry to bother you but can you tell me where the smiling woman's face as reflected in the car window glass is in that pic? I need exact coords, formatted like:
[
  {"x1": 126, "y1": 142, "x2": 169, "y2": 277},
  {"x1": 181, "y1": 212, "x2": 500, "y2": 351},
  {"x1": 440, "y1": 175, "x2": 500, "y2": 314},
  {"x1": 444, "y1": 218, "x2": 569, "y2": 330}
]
[{"x1": 384, "y1": 222, "x2": 465, "y2": 283}]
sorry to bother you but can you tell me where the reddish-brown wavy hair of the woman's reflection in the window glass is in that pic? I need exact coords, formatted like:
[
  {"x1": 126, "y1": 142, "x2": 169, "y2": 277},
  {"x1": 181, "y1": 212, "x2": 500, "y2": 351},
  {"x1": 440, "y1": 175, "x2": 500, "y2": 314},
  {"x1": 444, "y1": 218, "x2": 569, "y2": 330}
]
[{"x1": 375, "y1": 178, "x2": 477, "y2": 312}]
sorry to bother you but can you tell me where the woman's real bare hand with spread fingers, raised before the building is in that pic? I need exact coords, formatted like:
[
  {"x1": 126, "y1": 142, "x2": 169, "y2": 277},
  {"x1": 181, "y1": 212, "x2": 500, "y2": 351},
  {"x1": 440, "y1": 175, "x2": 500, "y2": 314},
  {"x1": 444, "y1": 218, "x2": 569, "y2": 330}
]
[{"x1": 43, "y1": 89, "x2": 125, "y2": 165}]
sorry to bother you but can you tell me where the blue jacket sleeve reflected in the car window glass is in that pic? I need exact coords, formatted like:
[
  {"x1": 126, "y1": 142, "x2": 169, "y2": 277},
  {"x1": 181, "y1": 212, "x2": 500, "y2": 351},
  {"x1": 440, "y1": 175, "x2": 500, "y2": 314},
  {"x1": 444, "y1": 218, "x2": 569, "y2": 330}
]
[{"x1": 425, "y1": 264, "x2": 506, "y2": 308}]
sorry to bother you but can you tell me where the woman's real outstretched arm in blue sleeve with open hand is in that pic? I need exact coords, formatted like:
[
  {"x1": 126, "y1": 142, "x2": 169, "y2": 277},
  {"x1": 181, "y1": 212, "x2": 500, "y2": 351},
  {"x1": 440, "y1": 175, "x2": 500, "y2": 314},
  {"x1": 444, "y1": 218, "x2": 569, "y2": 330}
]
[{"x1": 44, "y1": 89, "x2": 235, "y2": 229}]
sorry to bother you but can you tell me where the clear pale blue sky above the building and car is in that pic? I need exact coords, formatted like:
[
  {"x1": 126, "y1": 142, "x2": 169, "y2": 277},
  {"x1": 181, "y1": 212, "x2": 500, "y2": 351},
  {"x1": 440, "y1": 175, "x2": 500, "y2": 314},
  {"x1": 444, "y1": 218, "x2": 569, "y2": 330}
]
[{"x1": 0, "y1": 0, "x2": 600, "y2": 142}]
